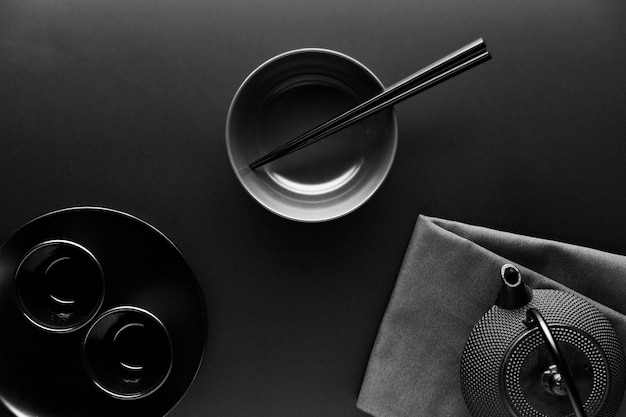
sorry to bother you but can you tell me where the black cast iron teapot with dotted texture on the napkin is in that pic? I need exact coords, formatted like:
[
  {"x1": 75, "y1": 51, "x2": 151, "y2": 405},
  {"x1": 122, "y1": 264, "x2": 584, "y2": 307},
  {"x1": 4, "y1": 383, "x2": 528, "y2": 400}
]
[{"x1": 461, "y1": 264, "x2": 626, "y2": 417}]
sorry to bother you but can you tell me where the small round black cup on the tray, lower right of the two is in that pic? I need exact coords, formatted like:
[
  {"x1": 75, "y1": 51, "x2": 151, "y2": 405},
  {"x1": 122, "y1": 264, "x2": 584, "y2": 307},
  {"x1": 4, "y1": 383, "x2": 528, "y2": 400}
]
[{"x1": 83, "y1": 306, "x2": 173, "y2": 400}]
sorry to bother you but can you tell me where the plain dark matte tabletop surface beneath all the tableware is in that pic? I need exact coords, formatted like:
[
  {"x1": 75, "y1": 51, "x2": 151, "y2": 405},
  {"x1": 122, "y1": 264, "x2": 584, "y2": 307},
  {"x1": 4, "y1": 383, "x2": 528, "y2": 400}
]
[{"x1": 0, "y1": 0, "x2": 626, "y2": 417}]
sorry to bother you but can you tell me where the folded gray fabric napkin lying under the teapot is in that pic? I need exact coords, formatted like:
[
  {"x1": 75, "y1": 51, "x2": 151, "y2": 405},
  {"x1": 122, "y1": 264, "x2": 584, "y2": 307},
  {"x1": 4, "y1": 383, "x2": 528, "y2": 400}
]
[{"x1": 357, "y1": 216, "x2": 626, "y2": 417}]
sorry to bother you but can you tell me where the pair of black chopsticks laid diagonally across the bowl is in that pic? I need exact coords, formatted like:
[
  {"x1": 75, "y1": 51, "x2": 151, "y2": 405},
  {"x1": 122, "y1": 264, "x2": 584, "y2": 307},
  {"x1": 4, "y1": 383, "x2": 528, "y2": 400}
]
[{"x1": 248, "y1": 38, "x2": 491, "y2": 169}]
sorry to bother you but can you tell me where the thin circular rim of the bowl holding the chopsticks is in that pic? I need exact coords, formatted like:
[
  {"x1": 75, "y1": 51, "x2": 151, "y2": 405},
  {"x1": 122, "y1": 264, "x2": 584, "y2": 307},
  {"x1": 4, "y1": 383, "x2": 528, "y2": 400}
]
[{"x1": 225, "y1": 47, "x2": 398, "y2": 223}]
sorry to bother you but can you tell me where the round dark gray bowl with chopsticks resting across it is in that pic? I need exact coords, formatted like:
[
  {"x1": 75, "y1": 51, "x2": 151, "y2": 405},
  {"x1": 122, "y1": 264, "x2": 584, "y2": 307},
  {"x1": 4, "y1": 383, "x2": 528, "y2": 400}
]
[{"x1": 226, "y1": 48, "x2": 397, "y2": 222}]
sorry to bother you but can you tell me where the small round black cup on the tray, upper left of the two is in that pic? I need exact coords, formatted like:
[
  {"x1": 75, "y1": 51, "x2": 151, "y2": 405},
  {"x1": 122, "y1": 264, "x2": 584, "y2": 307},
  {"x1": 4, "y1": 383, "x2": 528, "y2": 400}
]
[{"x1": 14, "y1": 240, "x2": 104, "y2": 333}]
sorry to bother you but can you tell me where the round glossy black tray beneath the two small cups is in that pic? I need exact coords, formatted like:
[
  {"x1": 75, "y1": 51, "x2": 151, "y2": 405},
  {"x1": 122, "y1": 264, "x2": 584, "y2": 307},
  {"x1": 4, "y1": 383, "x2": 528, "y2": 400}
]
[{"x1": 0, "y1": 207, "x2": 206, "y2": 417}]
